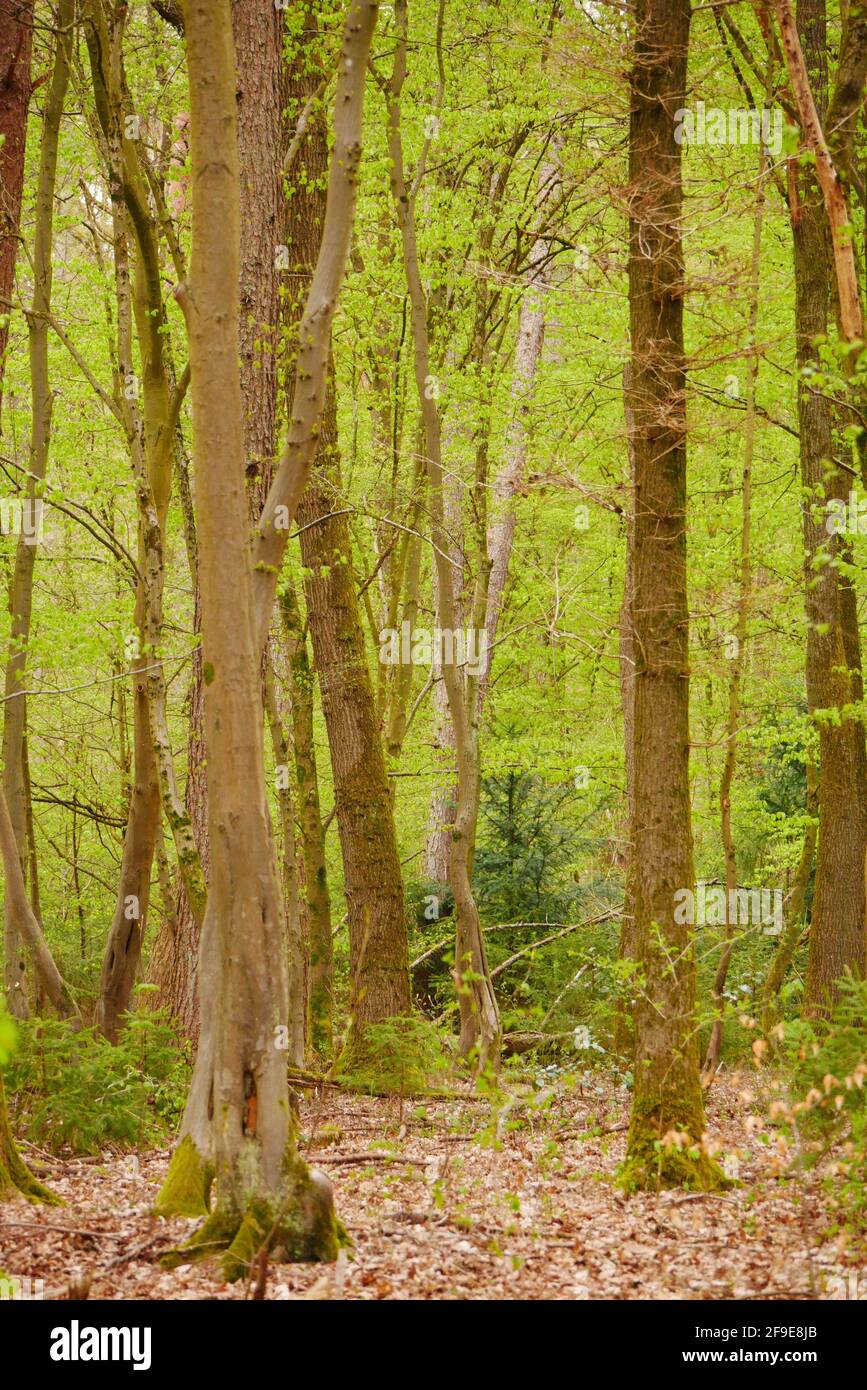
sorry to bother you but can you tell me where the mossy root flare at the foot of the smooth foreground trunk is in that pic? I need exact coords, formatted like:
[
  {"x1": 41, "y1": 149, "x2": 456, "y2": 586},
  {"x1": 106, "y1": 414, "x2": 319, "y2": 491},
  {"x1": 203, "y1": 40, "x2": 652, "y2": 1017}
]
[{"x1": 154, "y1": 1137, "x2": 342, "y2": 1282}]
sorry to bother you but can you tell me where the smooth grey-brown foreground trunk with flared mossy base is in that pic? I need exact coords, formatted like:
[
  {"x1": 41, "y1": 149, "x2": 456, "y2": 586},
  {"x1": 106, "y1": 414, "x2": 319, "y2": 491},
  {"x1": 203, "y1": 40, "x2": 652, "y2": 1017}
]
[{"x1": 158, "y1": 0, "x2": 337, "y2": 1277}]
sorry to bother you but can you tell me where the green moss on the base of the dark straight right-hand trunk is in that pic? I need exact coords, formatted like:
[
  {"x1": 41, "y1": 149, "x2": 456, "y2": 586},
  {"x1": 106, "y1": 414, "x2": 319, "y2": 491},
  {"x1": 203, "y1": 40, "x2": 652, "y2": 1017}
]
[{"x1": 617, "y1": 1106, "x2": 731, "y2": 1193}]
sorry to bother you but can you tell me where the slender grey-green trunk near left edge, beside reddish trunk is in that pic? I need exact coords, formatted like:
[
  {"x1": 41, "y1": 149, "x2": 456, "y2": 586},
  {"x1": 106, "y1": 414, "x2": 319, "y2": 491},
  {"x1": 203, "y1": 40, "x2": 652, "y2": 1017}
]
[{"x1": 3, "y1": 0, "x2": 75, "y2": 1017}]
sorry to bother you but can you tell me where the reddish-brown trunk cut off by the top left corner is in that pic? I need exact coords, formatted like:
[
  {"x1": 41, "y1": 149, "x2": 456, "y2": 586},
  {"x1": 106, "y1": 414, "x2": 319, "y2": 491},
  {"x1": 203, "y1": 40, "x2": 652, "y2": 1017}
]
[{"x1": 0, "y1": 0, "x2": 35, "y2": 409}]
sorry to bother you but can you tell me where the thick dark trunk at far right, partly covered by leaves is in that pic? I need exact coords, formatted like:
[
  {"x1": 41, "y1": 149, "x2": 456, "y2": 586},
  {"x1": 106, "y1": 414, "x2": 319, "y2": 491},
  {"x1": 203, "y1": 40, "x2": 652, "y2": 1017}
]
[{"x1": 792, "y1": 0, "x2": 867, "y2": 1015}]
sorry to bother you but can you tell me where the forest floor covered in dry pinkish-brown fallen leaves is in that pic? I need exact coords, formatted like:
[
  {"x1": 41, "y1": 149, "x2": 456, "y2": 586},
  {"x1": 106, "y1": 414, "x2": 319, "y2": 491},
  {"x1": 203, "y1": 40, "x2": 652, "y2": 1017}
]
[{"x1": 0, "y1": 1074, "x2": 867, "y2": 1300}]
